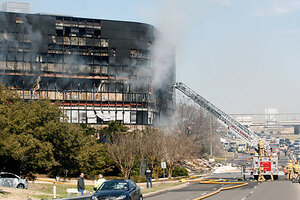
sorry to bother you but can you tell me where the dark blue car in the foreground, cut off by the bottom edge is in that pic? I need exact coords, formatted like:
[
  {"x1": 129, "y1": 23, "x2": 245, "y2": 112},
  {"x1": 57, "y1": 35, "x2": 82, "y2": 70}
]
[{"x1": 91, "y1": 180, "x2": 143, "y2": 200}]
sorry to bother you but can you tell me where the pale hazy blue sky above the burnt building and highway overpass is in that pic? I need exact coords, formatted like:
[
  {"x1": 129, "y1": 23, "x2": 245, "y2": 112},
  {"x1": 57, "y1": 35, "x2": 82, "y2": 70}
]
[{"x1": 0, "y1": 0, "x2": 300, "y2": 113}]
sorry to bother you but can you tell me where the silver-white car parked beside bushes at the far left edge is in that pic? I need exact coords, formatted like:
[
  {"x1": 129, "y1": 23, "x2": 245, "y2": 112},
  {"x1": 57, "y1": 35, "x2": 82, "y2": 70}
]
[{"x1": 0, "y1": 172, "x2": 28, "y2": 189}]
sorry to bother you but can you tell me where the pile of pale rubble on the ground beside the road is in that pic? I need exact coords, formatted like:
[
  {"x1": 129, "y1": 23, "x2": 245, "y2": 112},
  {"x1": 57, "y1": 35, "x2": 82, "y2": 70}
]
[{"x1": 182, "y1": 158, "x2": 213, "y2": 174}]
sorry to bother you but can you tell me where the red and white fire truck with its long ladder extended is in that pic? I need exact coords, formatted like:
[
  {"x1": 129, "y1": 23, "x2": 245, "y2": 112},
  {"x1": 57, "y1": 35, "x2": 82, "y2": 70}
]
[{"x1": 174, "y1": 82, "x2": 278, "y2": 180}]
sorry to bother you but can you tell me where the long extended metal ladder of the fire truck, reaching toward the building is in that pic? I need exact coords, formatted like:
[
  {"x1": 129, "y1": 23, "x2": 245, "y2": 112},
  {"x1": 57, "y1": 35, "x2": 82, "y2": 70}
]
[{"x1": 174, "y1": 82, "x2": 269, "y2": 147}]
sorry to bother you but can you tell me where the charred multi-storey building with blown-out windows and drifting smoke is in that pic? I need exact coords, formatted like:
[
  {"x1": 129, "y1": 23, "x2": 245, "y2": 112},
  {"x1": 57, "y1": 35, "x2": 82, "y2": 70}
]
[{"x1": 0, "y1": 12, "x2": 175, "y2": 128}]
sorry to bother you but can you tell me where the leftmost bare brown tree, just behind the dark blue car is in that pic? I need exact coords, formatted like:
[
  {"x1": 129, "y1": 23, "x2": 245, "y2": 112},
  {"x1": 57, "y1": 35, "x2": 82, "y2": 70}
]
[{"x1": 107, "y1": 133, "x2": 137, "y2": 178}]
